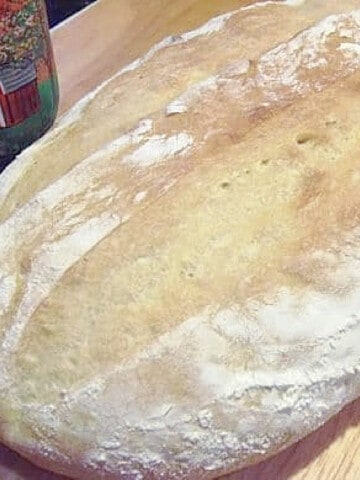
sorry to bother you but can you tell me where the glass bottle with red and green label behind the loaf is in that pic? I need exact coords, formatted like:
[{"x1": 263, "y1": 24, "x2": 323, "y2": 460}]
[{"x1": 0, "y1": 0, "x2": 59, "y2": 171}]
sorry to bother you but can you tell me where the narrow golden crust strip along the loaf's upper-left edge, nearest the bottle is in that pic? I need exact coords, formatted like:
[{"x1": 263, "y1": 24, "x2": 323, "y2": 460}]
[{"x1": 0, "y1": 0, "x2": 357, "y2": 219}]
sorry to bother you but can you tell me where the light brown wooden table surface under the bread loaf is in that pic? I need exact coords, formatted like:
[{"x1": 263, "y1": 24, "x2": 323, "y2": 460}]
[{"x1": 0, "y1": 0, "x2": 360, "y2": 480}]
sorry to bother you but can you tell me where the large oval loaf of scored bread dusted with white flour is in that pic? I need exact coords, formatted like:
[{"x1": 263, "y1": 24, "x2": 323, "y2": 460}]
[{"x1": 0, "y1": 0, "x2": 360, "y2": 480}]
